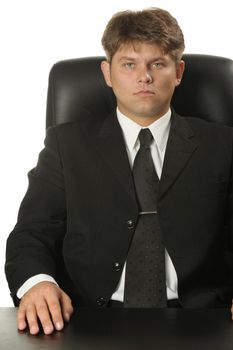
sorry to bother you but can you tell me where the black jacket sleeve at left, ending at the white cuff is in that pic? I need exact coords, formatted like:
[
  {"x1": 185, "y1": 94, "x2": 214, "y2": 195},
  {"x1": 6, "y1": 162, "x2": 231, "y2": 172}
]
[{"x1": 5, "y1": 128, "x2": 66, "y2": 304}]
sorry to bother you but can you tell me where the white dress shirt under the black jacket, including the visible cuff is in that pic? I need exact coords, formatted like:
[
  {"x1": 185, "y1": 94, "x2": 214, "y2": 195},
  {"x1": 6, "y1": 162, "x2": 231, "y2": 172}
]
[{"x1": 17, "y1": 109, "x2": 178, "y2": 301}]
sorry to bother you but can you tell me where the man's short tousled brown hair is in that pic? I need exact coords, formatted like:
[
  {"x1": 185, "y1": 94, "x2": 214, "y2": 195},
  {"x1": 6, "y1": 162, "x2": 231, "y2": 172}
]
[{"x1": 102, "y1": 7, "x2": 185, "y2": 62}]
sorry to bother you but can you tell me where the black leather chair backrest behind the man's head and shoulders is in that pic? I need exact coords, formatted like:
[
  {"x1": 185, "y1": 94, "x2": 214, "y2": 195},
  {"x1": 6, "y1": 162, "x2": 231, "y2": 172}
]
[{"x1": 46, "y1": 54, "x2": 233, "y2": 127}]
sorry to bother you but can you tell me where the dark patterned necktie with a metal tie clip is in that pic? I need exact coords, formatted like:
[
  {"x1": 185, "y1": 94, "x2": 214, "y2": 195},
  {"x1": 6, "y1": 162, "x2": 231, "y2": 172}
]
[{"x1": 124, "y1": 129, "x2": 166, "y2": 308}]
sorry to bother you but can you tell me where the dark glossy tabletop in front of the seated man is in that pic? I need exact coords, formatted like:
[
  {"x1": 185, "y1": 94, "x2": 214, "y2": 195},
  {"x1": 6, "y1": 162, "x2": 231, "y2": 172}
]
[{"x1": 0, "y1": 308, "x2": 233, "y2": 350}]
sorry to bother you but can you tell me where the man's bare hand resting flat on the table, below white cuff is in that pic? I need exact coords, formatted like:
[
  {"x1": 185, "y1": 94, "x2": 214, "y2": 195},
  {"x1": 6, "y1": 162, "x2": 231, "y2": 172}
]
[{"x1": 17, "y1": 281, "x2": 73, "y2": 334}]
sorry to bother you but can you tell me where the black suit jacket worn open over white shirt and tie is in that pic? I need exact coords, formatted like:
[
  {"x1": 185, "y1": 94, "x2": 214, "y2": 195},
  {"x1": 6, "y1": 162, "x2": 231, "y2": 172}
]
[{"x1": 6, "y1": 111, "x2": 233, "y2": 307}]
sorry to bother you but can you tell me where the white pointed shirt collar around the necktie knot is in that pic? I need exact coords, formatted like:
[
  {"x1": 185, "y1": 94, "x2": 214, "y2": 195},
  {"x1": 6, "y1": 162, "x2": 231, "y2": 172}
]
[{"x1": 117, "y1": 108, "x2": 171, "y2": 152}]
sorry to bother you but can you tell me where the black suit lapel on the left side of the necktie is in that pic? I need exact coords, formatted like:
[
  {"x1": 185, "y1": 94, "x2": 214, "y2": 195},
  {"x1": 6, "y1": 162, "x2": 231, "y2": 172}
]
[{"x1": 96, "y1": 113, "x2": 136, "y2": 202}]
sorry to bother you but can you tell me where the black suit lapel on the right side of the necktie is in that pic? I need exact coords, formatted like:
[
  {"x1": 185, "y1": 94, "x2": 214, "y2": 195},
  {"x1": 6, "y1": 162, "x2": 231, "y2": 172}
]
[{"x1": 159, "y1": 111, "x2": 198, "y2": 198}]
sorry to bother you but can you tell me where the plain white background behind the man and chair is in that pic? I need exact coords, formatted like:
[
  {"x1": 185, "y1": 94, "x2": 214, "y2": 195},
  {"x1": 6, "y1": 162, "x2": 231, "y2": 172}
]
[{"x1": 0, "y1": 0, "x2": 233, "y2": 306}]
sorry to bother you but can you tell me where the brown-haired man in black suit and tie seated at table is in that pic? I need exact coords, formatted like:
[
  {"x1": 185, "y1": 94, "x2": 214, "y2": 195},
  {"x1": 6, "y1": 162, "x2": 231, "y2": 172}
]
[{"x1": 6, "y1": 9, "x2": 233, "y2": 334}]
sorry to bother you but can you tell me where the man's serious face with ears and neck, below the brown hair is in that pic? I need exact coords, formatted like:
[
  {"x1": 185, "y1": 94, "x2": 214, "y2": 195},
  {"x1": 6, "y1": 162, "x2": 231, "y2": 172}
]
[{"x1": 101, "y1": 43, "x2": 184, "y2": 125}]
